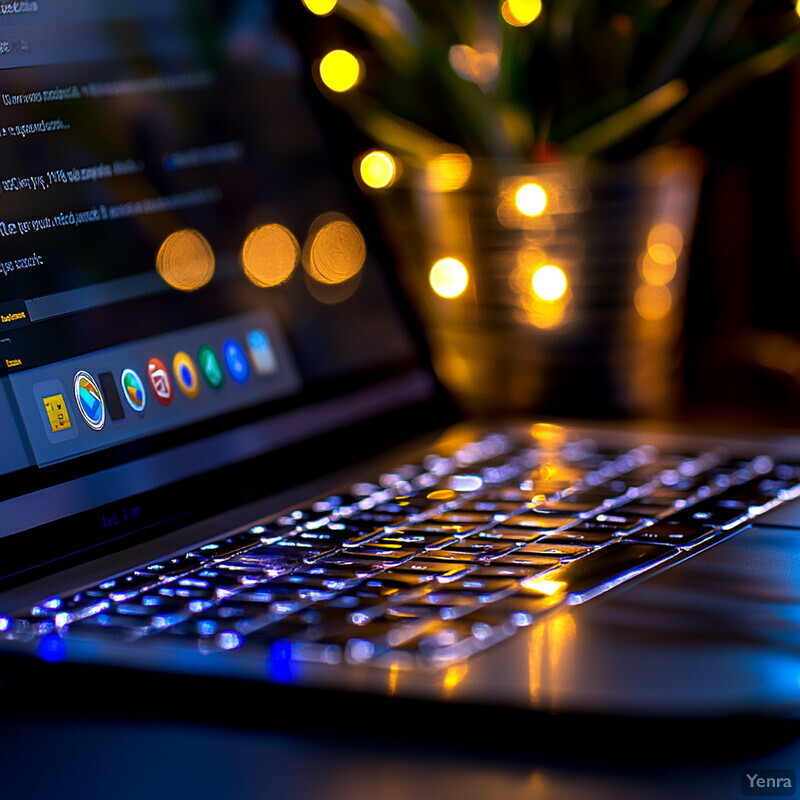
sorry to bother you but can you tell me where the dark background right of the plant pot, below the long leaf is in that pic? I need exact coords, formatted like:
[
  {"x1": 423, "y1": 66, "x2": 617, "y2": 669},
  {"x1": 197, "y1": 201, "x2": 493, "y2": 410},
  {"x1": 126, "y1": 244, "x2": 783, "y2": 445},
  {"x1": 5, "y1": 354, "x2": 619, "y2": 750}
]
[{"x1": 680, "y1": 63, "x2": 800, "y2": 427}]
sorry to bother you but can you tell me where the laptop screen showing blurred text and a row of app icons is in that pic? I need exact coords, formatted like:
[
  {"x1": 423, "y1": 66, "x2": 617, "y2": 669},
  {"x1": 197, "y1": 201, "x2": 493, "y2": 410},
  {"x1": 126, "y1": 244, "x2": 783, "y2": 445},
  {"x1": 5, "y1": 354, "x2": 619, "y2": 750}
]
[{"x1": 0, "y1": 0, "x2": 434, "y2": 575}]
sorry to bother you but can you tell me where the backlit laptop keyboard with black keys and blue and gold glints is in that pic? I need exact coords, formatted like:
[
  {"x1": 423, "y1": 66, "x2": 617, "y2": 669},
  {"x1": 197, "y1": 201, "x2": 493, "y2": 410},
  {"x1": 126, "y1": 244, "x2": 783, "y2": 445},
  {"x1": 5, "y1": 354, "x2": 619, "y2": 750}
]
[{"x1": 10, "y1": 426, "x2": 800, "y2": 667}]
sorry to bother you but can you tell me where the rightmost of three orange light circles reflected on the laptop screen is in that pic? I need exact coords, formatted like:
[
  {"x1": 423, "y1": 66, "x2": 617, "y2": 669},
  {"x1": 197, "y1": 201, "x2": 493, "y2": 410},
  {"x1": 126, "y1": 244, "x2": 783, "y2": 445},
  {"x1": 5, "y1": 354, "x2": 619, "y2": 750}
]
[{"x1": 302, "y1": 212, "x2": 367, "y2": 285}]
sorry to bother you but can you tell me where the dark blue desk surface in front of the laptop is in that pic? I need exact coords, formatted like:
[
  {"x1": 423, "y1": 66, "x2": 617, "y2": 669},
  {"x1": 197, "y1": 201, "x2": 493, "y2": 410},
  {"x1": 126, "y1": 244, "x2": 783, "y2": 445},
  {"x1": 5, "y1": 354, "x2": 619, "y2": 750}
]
[{"x1": 0, "y1": 701, "x2": 800, "y2": 800}]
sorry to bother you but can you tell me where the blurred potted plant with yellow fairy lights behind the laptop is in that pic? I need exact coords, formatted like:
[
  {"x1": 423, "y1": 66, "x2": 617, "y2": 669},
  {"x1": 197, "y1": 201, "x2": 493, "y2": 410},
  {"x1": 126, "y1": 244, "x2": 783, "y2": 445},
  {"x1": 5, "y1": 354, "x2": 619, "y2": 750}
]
[{"x1": 294, "y1": 0, "x2": 800, "y2": 415}]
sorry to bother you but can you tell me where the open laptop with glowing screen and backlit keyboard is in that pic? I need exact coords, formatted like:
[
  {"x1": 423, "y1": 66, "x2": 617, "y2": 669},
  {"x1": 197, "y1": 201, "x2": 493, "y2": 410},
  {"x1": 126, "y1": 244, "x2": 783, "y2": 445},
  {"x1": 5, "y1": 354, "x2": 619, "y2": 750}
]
[{"x1": 0, "y1": 0, "x2": 800, "y2": 718}]
